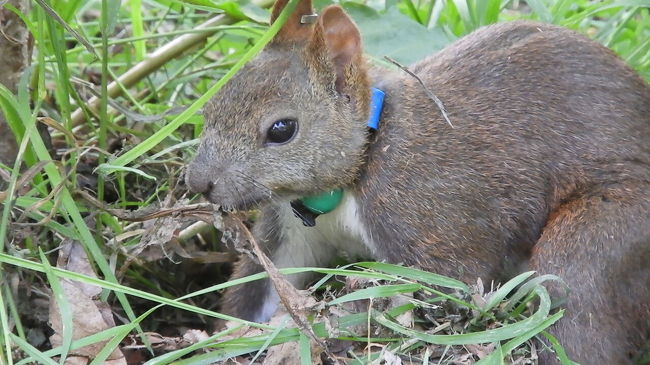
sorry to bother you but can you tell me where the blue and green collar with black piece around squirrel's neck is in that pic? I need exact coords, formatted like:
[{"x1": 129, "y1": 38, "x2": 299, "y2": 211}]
[{"x1": 291, "y1": 87, "x2": 385, "y2": 227}]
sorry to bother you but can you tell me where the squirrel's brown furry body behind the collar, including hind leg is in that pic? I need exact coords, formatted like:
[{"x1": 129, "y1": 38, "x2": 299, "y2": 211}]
[{"x1": 357, "y1": 22, "x2": 650, "y2": 364}]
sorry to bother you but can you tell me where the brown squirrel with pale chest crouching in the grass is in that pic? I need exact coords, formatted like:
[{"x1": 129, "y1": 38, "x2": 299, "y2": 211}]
[{"x1": 182, "y1": 0, "x2": 650, "y2": 364}]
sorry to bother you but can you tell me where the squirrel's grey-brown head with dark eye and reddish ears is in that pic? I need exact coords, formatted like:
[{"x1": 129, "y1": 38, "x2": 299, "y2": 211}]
[{"x1": 187, "y1": 0, "x2": 370, "y2": 209}]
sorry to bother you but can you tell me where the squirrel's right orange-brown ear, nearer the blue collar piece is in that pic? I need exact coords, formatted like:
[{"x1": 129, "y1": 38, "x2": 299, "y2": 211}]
[{"x1": 318, "y1": 5, "x2": 363, "y2": 92}]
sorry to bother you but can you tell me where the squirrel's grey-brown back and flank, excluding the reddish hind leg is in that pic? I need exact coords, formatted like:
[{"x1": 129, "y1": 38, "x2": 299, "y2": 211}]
[{"x1": 359, "y1": 21, "x2": 650, "y2": 277}]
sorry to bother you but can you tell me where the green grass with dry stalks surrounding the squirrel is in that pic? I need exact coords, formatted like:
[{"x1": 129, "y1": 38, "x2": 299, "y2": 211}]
[{"x1": 0, "y1": 0, "x2": 650, "y2": 364}]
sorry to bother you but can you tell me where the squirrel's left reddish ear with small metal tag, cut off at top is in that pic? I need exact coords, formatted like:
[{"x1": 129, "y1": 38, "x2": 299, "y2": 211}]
[{"x1": 271, "y1": 0, "x2": 314, "y2": 43}]
